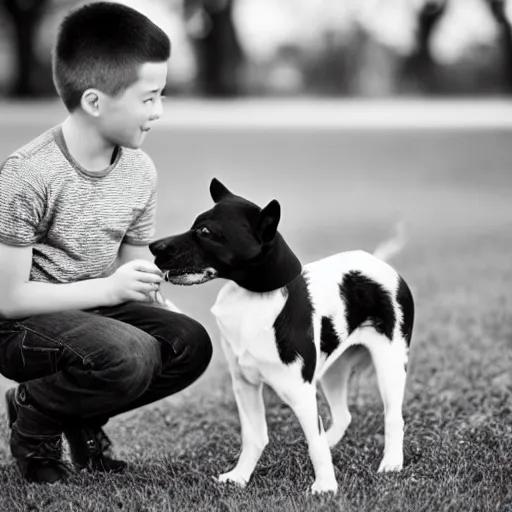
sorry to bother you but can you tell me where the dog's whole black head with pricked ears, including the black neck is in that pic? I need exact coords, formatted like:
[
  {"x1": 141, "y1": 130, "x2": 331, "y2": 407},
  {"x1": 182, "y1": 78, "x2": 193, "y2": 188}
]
[{"x1": 149, "y1": 178, "x2": 300, "y2": 291}]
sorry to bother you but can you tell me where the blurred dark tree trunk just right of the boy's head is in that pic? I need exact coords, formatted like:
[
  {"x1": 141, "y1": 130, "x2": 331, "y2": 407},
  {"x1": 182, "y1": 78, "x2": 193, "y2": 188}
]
[{"x1": 184, "y1": 0, "x2": 244, "y2": 96}]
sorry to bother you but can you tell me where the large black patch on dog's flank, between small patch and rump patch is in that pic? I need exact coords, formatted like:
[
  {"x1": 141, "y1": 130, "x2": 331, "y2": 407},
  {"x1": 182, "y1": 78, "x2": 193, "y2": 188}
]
[{"x1": 340, "y1": 270, "x2": 396, "y2": 340}]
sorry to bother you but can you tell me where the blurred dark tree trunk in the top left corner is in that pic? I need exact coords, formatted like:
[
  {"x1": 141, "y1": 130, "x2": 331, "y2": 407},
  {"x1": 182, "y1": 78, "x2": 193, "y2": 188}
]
[{"x1": 0, "y1": 0, "x2": 48, "y2": 97}]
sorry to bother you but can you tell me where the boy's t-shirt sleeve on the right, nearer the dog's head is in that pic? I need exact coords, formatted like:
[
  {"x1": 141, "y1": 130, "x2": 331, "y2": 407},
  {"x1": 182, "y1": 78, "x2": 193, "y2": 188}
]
[{"x1": 123, "y1": 155, "x2": 157, "y2": 245}]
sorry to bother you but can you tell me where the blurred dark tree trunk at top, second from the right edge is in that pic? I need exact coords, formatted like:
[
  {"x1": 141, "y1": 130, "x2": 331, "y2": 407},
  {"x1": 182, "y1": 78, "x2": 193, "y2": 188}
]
[{"x1": 402, "y1": 0, "x2": 448, "y2": 92}]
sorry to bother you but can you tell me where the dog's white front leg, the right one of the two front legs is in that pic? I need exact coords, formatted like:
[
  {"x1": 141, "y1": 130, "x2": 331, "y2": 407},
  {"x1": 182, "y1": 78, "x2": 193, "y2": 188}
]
[{"x1": 271, "y1": 383, "x2": 338, "y2": 494}]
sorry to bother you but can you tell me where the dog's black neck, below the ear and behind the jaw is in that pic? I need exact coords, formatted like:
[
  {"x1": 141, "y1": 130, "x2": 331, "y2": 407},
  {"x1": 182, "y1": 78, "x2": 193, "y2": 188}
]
[{"x1": 230, "y1": 233, "x2": 302, "y2": 293}]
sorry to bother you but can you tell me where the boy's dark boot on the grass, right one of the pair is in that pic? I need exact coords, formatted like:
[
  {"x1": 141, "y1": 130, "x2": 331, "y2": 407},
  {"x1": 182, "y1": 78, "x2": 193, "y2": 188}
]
[{"x1": 64, "y1": 425, "x2": 127, "y2": 473}]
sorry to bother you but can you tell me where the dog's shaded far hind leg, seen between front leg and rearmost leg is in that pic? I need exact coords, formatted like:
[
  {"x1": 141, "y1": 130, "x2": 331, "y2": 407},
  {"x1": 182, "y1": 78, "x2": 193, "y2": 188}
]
[{"x1": 320, "y1": 346, "x2": 369, "y2": 447}]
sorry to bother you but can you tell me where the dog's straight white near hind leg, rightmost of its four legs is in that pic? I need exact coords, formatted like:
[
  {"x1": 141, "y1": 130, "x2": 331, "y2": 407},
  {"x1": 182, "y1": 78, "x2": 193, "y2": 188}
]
[{"x1": 365, "y1": 330, "x2": 407, "y2": 472}]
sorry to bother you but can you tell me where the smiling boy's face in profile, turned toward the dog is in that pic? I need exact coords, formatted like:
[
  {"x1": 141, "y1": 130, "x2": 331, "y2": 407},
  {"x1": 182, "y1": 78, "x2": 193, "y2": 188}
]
[{"x1": 98, "y1": 62, "x2": 167, "y2": 149}]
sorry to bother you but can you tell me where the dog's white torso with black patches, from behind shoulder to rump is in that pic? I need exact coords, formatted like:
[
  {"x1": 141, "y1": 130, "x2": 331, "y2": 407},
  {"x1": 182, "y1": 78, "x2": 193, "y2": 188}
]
[{"x1": 303, "y1": 251, "x2": 414, "y2": 377}]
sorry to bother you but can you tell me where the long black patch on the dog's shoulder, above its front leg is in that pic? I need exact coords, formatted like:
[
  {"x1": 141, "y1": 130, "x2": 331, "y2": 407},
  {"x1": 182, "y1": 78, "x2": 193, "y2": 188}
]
[{"x1": 274, "y1": 273, "x2": 316, "y2": 382}]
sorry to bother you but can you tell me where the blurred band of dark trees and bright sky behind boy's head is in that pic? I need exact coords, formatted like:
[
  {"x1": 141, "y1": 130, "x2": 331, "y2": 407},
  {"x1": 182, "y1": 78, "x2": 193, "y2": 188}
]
[{"x1": 0, "y1": 0, "x2": 512, "y2": 98}]
